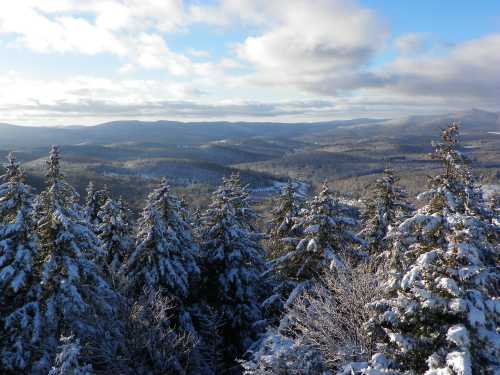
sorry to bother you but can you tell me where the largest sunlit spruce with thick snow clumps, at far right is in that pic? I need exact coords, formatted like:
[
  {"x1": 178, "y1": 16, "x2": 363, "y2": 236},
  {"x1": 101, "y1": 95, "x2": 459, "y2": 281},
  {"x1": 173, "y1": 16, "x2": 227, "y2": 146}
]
[{"x1": 370, "y1": 124, "x2": 500, "y2": 375}]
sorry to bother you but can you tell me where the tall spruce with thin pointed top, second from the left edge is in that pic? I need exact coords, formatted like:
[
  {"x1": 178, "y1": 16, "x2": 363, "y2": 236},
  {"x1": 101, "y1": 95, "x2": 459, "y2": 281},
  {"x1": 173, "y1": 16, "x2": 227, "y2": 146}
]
[{"x1": 34, "y1": 146, "x2": 119, "y2": 372}]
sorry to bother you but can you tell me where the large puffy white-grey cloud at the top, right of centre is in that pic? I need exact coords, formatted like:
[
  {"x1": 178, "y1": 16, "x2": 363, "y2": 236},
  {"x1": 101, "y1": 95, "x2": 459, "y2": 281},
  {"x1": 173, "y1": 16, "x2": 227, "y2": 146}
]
[{"x1": 190, "y1": 0, "x2": 388, "y2": 95}]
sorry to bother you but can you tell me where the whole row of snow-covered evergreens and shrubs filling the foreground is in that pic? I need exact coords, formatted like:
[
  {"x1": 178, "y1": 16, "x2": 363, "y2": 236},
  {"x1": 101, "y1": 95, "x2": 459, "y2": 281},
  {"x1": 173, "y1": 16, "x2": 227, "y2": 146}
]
[{"x1": 0, "y1": 124, "x2": 500, "y2": 375}]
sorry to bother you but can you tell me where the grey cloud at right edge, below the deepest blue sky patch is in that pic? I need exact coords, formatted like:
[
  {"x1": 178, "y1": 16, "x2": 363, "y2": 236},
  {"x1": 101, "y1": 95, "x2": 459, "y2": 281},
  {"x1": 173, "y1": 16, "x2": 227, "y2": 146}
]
[{"x1": 368, "y1": 34, "x2": 500, "y2": 106}]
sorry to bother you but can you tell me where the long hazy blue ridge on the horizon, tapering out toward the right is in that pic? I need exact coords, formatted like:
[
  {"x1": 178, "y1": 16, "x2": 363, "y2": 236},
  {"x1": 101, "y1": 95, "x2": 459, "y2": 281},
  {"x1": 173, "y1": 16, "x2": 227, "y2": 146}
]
[{"x1": 0, "y1": 119, "x2": 380, "y2": 148}]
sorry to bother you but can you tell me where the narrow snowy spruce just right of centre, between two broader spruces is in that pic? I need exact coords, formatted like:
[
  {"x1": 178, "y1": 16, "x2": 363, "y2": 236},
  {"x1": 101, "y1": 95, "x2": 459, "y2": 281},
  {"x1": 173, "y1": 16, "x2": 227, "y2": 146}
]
[{"x1": 267, "y1": 181, "x2": 301, "y2": 259}]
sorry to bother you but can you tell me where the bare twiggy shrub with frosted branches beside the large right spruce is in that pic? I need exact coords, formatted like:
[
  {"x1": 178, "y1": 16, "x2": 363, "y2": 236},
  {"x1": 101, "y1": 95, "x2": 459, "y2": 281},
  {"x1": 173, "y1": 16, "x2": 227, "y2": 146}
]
[{"x1": 286, "y1": 264, "x2": 381, "y2": 370}]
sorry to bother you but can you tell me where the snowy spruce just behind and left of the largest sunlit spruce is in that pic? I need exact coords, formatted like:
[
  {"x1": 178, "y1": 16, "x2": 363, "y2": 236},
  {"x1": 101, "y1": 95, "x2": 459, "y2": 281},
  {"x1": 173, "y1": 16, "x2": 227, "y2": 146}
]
[{"x1": 358, "y1": 168, "x2": 413, "y2": 256}]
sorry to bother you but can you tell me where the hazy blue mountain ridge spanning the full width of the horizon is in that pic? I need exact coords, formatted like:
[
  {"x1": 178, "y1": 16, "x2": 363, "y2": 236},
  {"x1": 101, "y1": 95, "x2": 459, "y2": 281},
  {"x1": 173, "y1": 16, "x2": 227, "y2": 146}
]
[{"x1": 0, "y1": 109, "x2": 500, "y2": 149}]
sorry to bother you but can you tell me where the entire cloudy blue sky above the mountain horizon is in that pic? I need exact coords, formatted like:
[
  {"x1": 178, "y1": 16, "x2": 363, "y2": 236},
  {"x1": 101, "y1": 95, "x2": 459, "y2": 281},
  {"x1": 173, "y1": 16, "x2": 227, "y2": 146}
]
[{"x1": 0, "y1": 0, "x2": 500, "y2": 125}]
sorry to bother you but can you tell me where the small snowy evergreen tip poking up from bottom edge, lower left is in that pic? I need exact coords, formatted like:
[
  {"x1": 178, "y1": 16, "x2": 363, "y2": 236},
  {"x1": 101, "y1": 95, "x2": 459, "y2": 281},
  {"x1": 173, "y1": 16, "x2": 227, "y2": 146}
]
[{"x1": 49, "y1": 336, "x2": 94, "y2": 375}]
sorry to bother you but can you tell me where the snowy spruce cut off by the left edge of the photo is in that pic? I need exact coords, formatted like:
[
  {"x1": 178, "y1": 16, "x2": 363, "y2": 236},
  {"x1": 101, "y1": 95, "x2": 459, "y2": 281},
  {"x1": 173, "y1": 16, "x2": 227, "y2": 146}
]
[{"x1": 0, "y1": 153, "x2": 41, "y2": 373}]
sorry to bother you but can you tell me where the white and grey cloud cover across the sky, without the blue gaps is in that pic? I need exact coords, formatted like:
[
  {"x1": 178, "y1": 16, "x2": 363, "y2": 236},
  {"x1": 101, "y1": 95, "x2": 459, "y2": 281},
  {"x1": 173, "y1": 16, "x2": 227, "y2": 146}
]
[{"x1": 0, "y1": 0, "x2": 500, "y2": 119}]
